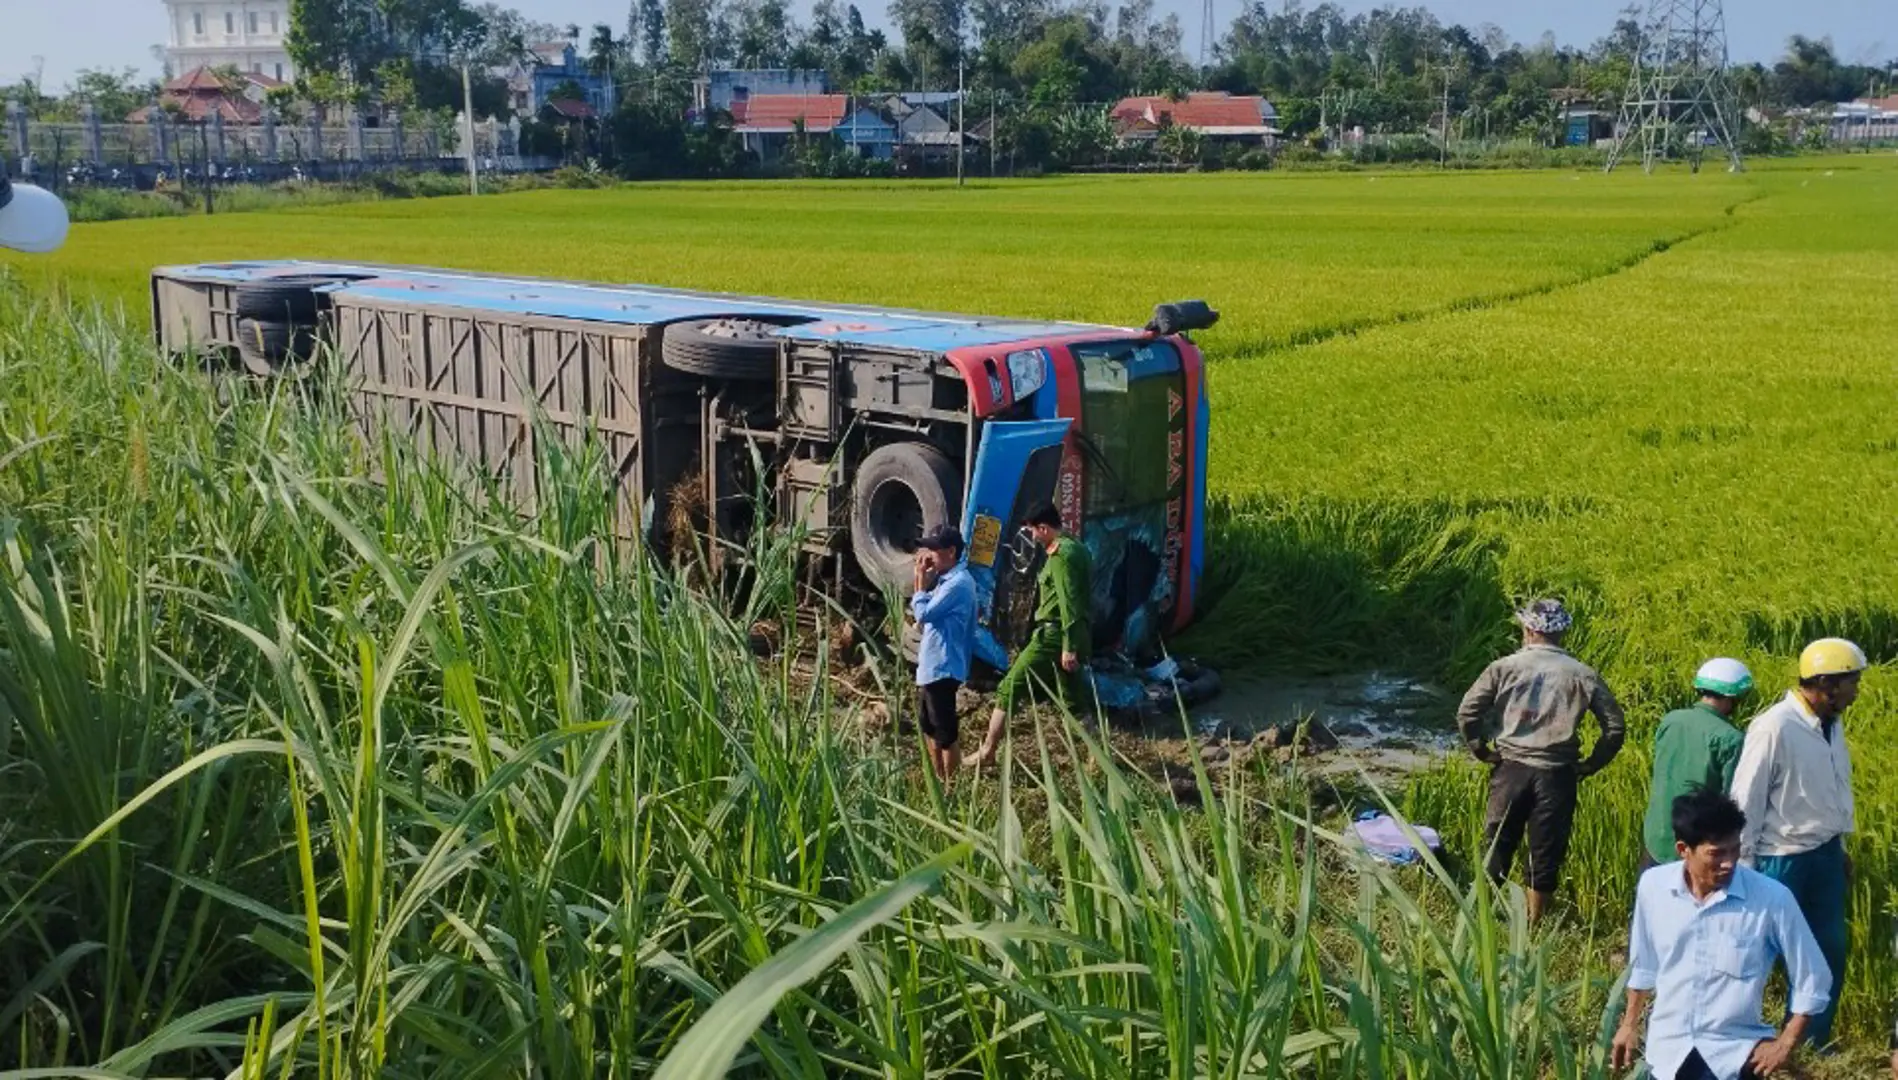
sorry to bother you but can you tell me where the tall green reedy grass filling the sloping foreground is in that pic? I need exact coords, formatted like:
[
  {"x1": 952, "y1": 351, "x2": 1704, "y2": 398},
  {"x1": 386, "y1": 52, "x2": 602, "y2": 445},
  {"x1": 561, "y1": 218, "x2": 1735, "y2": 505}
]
[{"x1": 0, "y1": 283, "x2": 1624, "y2": 1078}]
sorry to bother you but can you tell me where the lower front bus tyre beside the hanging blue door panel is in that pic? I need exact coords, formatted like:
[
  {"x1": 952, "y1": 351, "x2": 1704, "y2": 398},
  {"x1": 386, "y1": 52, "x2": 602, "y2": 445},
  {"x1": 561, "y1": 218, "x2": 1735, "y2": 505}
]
[{"x1": 850, "y1": 442, "x2": 962, "y2": 594}]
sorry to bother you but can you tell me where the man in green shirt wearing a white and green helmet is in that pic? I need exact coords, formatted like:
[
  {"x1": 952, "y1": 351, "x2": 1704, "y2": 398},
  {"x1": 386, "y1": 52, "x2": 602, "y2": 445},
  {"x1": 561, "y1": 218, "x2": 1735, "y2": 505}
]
[{"x1": 1642, "y1": 657, "x2": 1754, "y2": 869}]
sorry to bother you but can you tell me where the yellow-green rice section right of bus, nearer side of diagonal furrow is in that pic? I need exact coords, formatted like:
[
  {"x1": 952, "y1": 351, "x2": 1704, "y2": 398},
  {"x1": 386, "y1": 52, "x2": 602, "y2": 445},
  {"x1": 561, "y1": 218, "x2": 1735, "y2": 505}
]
[{"x1": 1207, "y1": 161, "x2": 1898, "y2": 1038}]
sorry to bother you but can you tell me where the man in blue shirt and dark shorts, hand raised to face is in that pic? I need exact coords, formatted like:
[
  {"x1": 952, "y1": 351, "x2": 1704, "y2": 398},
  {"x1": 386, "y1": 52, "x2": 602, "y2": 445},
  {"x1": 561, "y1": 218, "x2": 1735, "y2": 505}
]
[{"x1": 909, "y1": 526, "x2": 976, "y2": 786}]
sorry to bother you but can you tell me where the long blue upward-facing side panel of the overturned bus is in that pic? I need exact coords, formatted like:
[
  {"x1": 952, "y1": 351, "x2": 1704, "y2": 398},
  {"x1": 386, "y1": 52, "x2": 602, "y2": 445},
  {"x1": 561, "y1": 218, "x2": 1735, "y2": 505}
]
[{"x1": 156, "y1": 260, "x2": 1139, "y2": 353}]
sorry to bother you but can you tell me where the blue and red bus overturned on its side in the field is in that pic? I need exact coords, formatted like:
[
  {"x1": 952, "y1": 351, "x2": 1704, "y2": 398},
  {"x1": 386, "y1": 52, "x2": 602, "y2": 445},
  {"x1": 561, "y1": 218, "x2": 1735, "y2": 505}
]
[{"x1": 152, "y1": 262, "x2": 1217, "y2": 668}]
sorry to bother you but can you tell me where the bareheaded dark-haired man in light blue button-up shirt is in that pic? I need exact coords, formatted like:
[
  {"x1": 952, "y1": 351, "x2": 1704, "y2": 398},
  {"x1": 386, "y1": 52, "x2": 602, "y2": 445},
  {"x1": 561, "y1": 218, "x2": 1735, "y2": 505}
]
[{"x1": 1613, "y1": 790, "x2": 1832, "y2": 1080}]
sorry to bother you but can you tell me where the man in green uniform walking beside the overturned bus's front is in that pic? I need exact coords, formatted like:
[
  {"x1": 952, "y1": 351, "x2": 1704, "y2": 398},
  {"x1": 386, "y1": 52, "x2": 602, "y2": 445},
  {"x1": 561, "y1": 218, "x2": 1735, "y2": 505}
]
[{"x1": 970, "y1": 503, "x2": 1093, "y2": 765}]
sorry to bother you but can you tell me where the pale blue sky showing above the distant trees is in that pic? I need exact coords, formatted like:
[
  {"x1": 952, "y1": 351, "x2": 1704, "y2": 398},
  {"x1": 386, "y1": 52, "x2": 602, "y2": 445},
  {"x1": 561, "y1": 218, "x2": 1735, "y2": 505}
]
[{"x1": 0, "y1": 0, "x2": 1898, "y2": 93}]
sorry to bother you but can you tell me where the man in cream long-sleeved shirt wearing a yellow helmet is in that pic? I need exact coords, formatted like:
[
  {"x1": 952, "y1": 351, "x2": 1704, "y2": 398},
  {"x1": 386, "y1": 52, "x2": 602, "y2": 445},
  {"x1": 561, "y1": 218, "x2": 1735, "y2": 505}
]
[{"x1": 1733, "y1": 638, "x2": 1866, "y2": 1046}]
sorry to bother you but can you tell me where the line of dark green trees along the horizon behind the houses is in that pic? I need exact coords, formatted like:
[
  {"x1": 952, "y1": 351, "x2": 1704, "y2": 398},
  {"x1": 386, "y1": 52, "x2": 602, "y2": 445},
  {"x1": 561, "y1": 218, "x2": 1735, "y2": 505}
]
[{"x1": 15, "y1": 0, "x2": 1898, "y2": 175}]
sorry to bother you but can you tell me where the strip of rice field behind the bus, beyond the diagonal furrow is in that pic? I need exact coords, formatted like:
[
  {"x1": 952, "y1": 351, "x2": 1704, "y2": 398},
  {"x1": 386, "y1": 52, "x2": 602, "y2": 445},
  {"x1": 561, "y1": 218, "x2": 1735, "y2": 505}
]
[{"x1": 15, "y1": 173, "x2": 1754, "y2": 357}]
